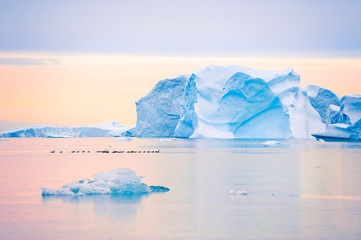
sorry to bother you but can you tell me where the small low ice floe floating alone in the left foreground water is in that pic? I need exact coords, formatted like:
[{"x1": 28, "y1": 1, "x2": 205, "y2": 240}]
[{"x1": 41, "y1": 168, "x2": 169, "y2": 196}]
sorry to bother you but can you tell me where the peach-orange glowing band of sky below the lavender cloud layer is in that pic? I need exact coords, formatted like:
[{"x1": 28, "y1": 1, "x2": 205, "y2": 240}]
[{"x1": 0, "y1": 54, "x2": 361, "y2": 125}]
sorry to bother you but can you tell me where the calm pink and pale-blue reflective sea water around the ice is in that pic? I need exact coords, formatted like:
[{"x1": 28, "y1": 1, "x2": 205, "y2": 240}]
[{"x1": 0, "y1": 138, "x2": 361, "y2": 240}]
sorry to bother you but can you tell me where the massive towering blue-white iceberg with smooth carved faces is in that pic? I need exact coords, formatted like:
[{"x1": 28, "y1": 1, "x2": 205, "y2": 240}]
[{"x1": 129, "y1": 65, "x2": 354, "y2": 138}]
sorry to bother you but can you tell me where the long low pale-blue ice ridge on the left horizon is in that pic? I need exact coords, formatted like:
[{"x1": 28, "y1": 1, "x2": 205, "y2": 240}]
[{"x1": 0, "y1": 121, "x2": 132, "y2": 138}]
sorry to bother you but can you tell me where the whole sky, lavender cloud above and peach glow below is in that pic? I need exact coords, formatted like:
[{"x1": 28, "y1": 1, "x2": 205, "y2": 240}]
[{"x1": 0, "y1": 0, "x2": 361, "y2": 129}]
